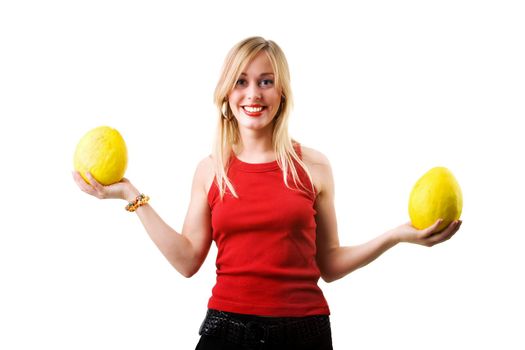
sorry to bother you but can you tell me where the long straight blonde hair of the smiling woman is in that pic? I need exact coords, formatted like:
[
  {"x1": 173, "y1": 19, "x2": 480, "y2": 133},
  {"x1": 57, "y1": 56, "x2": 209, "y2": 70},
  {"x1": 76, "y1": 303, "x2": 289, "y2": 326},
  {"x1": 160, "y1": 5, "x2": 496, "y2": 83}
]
[{"x1": 212, "y1": 37, "x2": 315, "y2": 198}]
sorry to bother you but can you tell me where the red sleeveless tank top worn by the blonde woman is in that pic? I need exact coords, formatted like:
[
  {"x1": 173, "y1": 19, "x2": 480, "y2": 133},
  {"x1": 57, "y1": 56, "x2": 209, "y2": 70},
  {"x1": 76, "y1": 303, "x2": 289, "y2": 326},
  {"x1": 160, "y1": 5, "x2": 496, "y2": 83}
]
[{"x1": 208, "y1": 145, "x2": 330, "y2": 317}]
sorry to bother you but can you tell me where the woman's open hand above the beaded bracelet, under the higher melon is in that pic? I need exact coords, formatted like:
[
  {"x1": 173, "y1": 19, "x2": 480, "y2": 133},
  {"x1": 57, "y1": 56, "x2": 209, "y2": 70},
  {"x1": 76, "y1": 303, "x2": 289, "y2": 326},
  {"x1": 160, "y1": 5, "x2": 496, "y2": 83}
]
[{"x1": 73, "y1": 171, "x2": 139, "y2": 201}]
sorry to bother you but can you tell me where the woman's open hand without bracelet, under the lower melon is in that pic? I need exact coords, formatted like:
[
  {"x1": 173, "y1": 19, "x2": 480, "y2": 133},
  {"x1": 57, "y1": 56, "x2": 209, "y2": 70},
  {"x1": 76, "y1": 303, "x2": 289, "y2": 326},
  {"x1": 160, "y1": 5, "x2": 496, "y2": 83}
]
[{"x1": 390, "y1": 219, "x2": 462, "y2": 247}]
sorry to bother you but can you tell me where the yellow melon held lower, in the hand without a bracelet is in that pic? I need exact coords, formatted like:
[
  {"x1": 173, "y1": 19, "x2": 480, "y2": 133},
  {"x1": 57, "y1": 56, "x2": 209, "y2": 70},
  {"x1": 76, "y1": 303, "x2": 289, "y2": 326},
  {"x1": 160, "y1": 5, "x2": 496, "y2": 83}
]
[{"x1": 408, "y1": 167, "x2": 463, "y2": 231}]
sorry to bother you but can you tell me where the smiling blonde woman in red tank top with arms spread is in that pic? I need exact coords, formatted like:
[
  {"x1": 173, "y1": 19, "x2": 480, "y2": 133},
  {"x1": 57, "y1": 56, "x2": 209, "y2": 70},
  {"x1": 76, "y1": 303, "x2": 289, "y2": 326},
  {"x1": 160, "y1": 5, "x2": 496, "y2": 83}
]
[{"x1": 74, "y1": 37, "x2": 461, "y2": 349}]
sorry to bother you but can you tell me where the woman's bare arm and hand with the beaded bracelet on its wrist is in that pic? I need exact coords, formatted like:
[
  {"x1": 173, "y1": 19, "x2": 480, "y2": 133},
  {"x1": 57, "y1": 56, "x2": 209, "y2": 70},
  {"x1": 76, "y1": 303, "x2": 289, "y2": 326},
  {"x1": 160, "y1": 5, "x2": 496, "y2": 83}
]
[{"x1": 73, "y1": 159, "x2": 213, "y2": 277}]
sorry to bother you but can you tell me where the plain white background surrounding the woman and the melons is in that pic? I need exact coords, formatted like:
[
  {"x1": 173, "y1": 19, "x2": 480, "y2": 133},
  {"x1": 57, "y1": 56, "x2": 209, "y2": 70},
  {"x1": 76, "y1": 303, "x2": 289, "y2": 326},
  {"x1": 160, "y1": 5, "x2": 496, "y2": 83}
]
[{"x1": 0, "y1": 0, "x2": 525, "y2": 350}]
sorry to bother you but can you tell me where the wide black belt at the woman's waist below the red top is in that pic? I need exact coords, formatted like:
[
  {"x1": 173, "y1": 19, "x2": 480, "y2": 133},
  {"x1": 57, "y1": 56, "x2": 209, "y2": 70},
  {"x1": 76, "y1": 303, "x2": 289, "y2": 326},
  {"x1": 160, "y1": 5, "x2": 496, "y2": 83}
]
[{"x1": 199, "y1": 309, "x2": 330, "y2": 344}]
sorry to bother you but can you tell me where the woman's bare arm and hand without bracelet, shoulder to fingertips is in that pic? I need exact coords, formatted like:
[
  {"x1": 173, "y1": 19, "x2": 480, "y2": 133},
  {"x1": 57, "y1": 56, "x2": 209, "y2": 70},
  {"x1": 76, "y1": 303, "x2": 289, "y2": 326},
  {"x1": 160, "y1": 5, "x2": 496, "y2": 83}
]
[{"x1": 304, "y1": 146, "x2": 461, "y2": 282}]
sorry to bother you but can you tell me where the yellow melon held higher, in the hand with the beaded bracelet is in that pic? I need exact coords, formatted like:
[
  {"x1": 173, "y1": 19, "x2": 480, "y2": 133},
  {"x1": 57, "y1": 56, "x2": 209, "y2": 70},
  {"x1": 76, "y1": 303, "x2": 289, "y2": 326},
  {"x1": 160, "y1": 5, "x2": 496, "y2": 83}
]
[{"x1": 73, "y1": 126, "x2": 128, "y2": 185}]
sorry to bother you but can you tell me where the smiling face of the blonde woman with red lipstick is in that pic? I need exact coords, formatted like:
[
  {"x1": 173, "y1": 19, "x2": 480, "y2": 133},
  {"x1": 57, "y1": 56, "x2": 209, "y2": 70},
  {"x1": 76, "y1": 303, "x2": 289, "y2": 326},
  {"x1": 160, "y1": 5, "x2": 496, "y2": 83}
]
[{"x1": 228, "y1": 51, "x2": 281, "y2": 130}]
